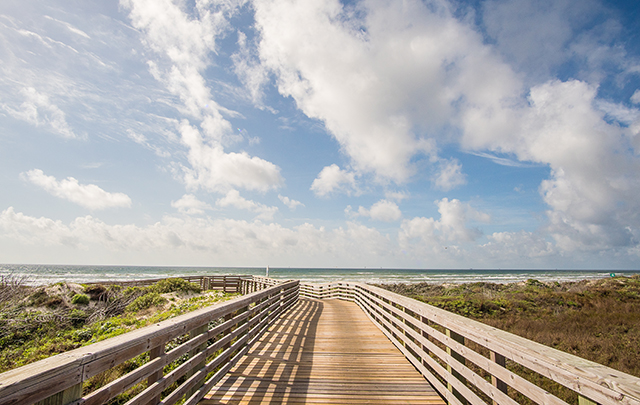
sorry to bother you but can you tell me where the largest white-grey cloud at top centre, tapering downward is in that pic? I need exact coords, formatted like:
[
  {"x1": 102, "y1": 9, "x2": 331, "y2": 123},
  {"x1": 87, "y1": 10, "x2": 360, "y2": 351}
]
[{"x1": 253, "y1": 0, "x2": 502, "y2": 182}]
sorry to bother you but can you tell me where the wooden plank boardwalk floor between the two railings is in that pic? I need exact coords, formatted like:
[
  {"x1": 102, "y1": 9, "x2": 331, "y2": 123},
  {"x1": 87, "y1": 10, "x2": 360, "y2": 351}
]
[{"x1": 200, "y1": 299, "x2": 444, "y2": 405}]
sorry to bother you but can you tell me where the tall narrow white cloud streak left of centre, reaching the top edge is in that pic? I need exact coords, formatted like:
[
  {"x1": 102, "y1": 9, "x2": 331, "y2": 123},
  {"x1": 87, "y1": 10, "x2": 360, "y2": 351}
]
[{"x1": 121, "y1": 0, "x2": 283, "y2": 192}]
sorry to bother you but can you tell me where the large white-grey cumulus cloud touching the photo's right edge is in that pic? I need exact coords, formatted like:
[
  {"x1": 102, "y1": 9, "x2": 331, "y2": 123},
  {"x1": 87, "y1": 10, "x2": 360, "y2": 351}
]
[{"x1": 463, "y1": 80, "x2": 640, "y2": 251}]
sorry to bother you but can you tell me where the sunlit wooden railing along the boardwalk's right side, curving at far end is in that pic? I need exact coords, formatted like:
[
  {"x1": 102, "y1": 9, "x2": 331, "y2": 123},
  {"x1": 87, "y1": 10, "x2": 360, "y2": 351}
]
[{"x1": 300, "y1": 283, "x2": 640, "y2": 405}]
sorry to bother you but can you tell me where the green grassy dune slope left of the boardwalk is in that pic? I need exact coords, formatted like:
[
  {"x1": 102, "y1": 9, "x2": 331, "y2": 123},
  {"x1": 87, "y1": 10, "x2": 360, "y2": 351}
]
[{"x1": 0, "y1": 276, "x2": 236, "y2": 373}]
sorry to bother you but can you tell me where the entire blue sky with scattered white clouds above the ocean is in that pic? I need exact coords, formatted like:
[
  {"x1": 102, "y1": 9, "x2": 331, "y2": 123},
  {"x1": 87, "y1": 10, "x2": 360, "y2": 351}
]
[{"x1": 0, "y1": 0, "x2": 640, "y2": 269}]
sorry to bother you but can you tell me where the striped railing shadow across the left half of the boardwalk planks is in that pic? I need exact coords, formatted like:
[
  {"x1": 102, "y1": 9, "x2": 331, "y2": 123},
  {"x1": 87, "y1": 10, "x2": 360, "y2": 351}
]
[{"x1": 205, "y1": 300, "x2": 324, "y2": 404}]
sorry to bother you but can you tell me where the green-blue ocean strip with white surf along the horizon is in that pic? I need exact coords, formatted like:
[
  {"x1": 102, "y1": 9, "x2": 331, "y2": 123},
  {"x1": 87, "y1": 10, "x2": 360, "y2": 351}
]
[{"x1": 0, "y1": 264, "x2": 640, "y2": 285}]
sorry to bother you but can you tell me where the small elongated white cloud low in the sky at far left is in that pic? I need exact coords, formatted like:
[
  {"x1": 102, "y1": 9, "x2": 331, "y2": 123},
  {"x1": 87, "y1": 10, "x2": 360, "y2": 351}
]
[{"x1": 23, "y1": 169, "x2": 131, "y2": 210}]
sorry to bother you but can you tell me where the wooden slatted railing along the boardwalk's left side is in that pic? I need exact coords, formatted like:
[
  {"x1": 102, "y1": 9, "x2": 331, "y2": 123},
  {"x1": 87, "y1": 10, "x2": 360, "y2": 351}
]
[{"x1": 0, "y1": 279, "x2": 299, "y2": 405}]
